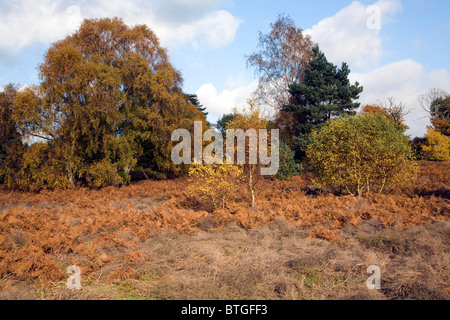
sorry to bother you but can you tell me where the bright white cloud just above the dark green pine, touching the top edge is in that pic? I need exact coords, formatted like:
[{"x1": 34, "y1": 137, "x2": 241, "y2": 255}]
[{"x1": 305, "y1": 0, "x2": 401, "y2": 69}]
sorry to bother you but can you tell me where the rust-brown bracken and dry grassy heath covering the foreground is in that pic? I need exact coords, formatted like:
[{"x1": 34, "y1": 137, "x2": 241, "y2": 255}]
[{"x1": 0, "y1": 162, "x2": 450, "y2": 300}]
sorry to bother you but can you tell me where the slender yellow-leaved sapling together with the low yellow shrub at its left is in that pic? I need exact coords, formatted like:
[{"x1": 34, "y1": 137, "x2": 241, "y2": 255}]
[{"x1": 189, "y1": 101, "x2": 271, "y2": 208}]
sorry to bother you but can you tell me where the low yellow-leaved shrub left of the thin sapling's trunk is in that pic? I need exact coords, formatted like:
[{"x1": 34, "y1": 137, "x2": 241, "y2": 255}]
[{"x1": 189, "y1": 164, "x2": 244, "y2": 209}]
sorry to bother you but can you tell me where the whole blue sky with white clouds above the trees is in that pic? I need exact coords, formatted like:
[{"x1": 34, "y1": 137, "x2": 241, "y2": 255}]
[{"x1": 0, "y1": 0, "x2": 450, "y2": 137}]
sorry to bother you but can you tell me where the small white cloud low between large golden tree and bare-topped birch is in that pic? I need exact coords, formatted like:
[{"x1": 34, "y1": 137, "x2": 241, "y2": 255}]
[{"x1": 196, "y1": 82, "x2": 258, "y2": 119}]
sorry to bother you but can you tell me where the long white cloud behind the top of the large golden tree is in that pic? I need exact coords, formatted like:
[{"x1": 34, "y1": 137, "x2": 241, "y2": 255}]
[{"x1": 0, "y1": 0, "x2": 242, "y2": 56}]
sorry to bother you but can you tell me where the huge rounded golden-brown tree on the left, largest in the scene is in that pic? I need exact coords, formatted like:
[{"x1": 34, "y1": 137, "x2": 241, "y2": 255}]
[{"x1": 1, "y1": 18, "x2": 206, "y2": 190}]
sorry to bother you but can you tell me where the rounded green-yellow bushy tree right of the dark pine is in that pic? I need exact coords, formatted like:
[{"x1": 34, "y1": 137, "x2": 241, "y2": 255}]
[{"x1": 307, "y1": 114, "x2": 417, "y2": 195}]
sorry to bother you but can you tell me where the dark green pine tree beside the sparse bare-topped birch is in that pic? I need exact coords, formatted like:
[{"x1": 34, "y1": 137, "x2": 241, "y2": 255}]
[{"x1": 282, "y1": 46, "x2": 363, "y2": 159}]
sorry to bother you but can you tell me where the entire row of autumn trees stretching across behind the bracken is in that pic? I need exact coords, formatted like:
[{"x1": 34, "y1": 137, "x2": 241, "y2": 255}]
[{"x1": 0, "y1": 15, "x2": 450, "y2": 195}]
